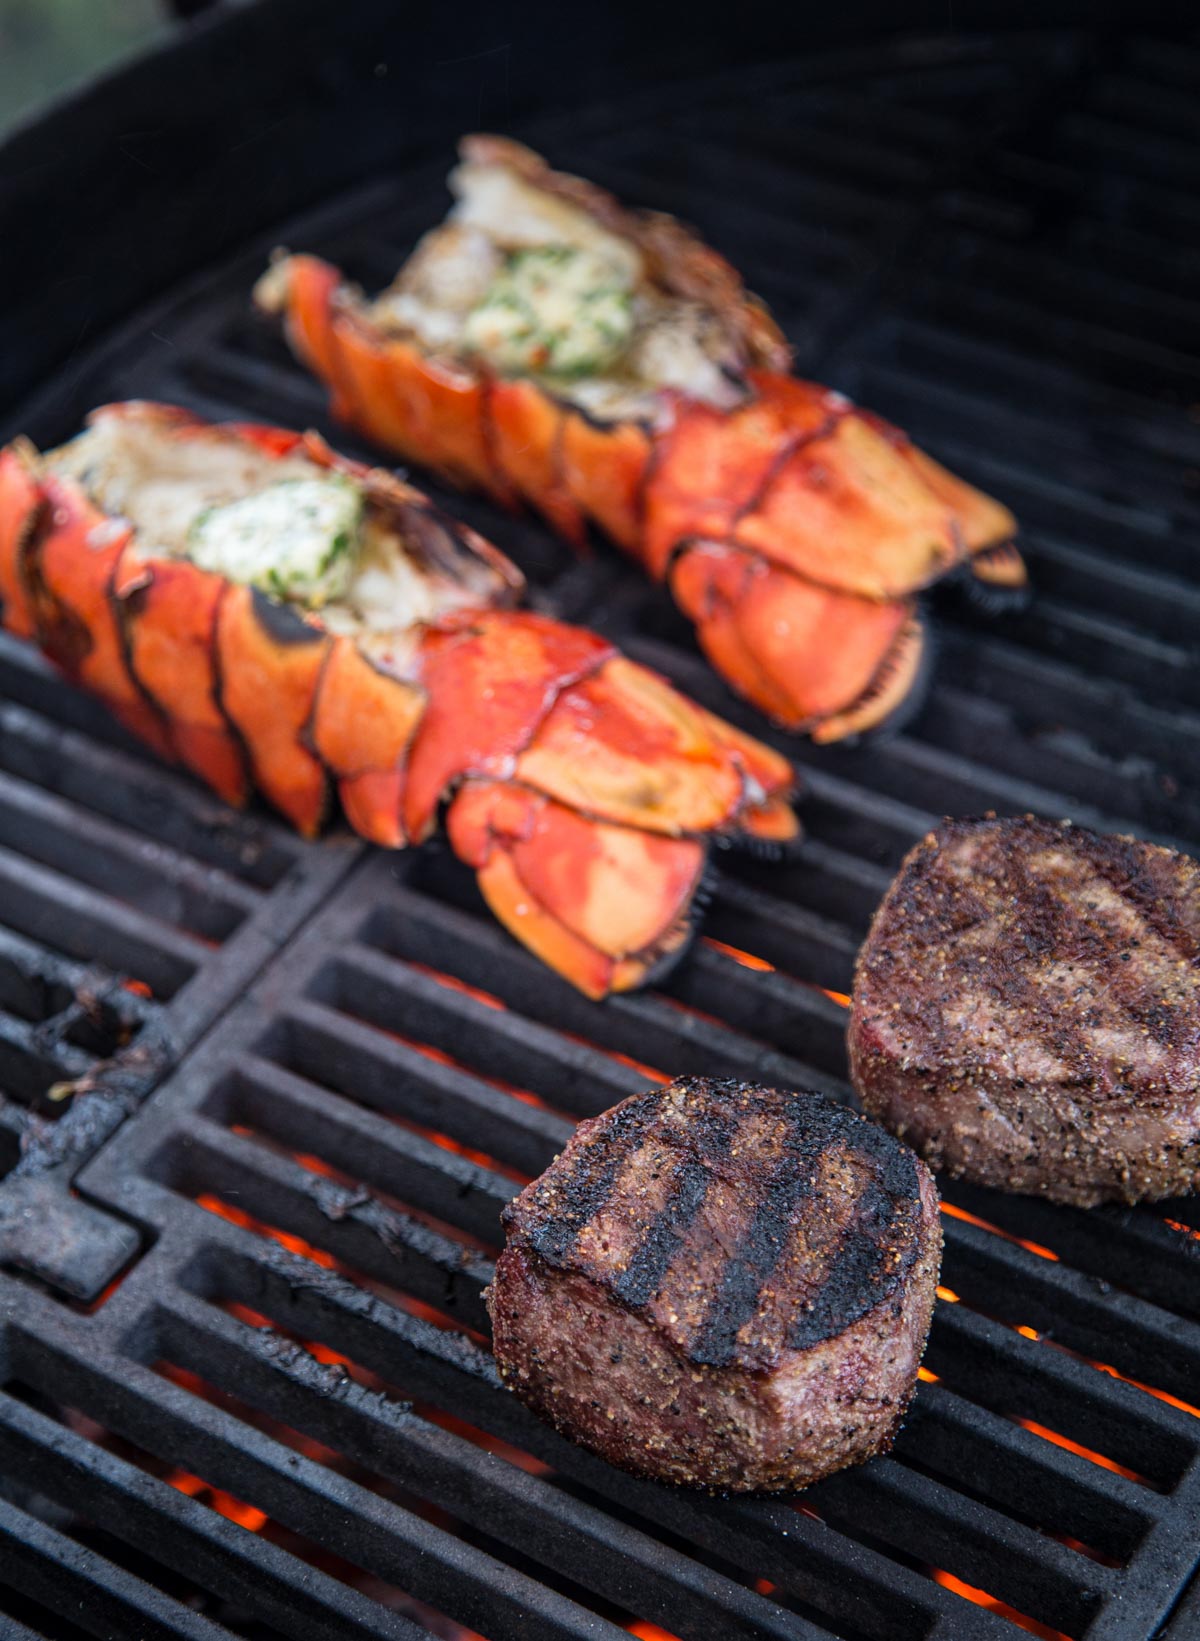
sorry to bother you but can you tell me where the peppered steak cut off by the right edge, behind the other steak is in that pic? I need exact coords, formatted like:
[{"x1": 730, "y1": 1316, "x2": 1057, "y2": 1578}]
[{"x1": 849, "y1": 817, "x2": 1200, "y2": 1206}]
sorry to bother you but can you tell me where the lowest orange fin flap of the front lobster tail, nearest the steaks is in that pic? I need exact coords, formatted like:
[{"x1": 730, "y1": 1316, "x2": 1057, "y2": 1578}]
[{"x1": 447, "y1": 781, "x2": 706, "y2": 998}]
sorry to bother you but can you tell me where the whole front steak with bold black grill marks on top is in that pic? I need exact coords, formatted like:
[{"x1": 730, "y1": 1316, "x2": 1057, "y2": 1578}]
[{"x1": 488, "y1": 1078, "x2": 941, "y2": 1492}]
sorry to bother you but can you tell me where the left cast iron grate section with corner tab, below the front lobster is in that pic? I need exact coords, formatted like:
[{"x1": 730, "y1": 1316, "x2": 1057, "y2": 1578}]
[{"x1": 0, "y1": 635, "x2": 356, "y2": 1301}]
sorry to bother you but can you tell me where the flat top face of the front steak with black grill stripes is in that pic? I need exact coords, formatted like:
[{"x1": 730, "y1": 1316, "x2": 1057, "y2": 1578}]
[{"x1": 504, "y1": 1078, "x2": 919, "y2": 1367}]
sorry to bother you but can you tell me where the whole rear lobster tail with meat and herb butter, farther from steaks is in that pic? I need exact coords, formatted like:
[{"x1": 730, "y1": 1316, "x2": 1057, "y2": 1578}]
[{"x1": 256, "y1": 136, "x2": 1024, "y2": 740}]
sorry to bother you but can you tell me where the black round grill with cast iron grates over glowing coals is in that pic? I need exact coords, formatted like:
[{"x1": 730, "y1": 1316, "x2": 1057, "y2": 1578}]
[{"x1": 0, "y1": 3, "x2": 1200, "y2": 1641}]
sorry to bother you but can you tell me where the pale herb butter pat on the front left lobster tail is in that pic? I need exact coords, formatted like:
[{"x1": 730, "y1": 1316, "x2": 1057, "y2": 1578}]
[{"x1": 187, "y1": 476, "x2": 363, "y2": 609}]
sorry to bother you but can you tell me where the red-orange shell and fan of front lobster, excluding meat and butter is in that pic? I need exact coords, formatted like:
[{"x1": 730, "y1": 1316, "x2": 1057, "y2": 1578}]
[{"x1": 0, "y1": 404, "x2": 798, "y2": 996}]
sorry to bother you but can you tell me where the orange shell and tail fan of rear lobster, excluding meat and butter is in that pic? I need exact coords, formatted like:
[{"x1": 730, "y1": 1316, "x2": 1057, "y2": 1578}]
[{"x1": 258, "y1": 136, "x2": 1026, "y2": 742}]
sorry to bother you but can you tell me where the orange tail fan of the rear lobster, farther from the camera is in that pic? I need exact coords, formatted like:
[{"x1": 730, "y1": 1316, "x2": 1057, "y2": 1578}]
[{"x1": 640, "y1": 371, "x2": 1028, "y2": 742}]
